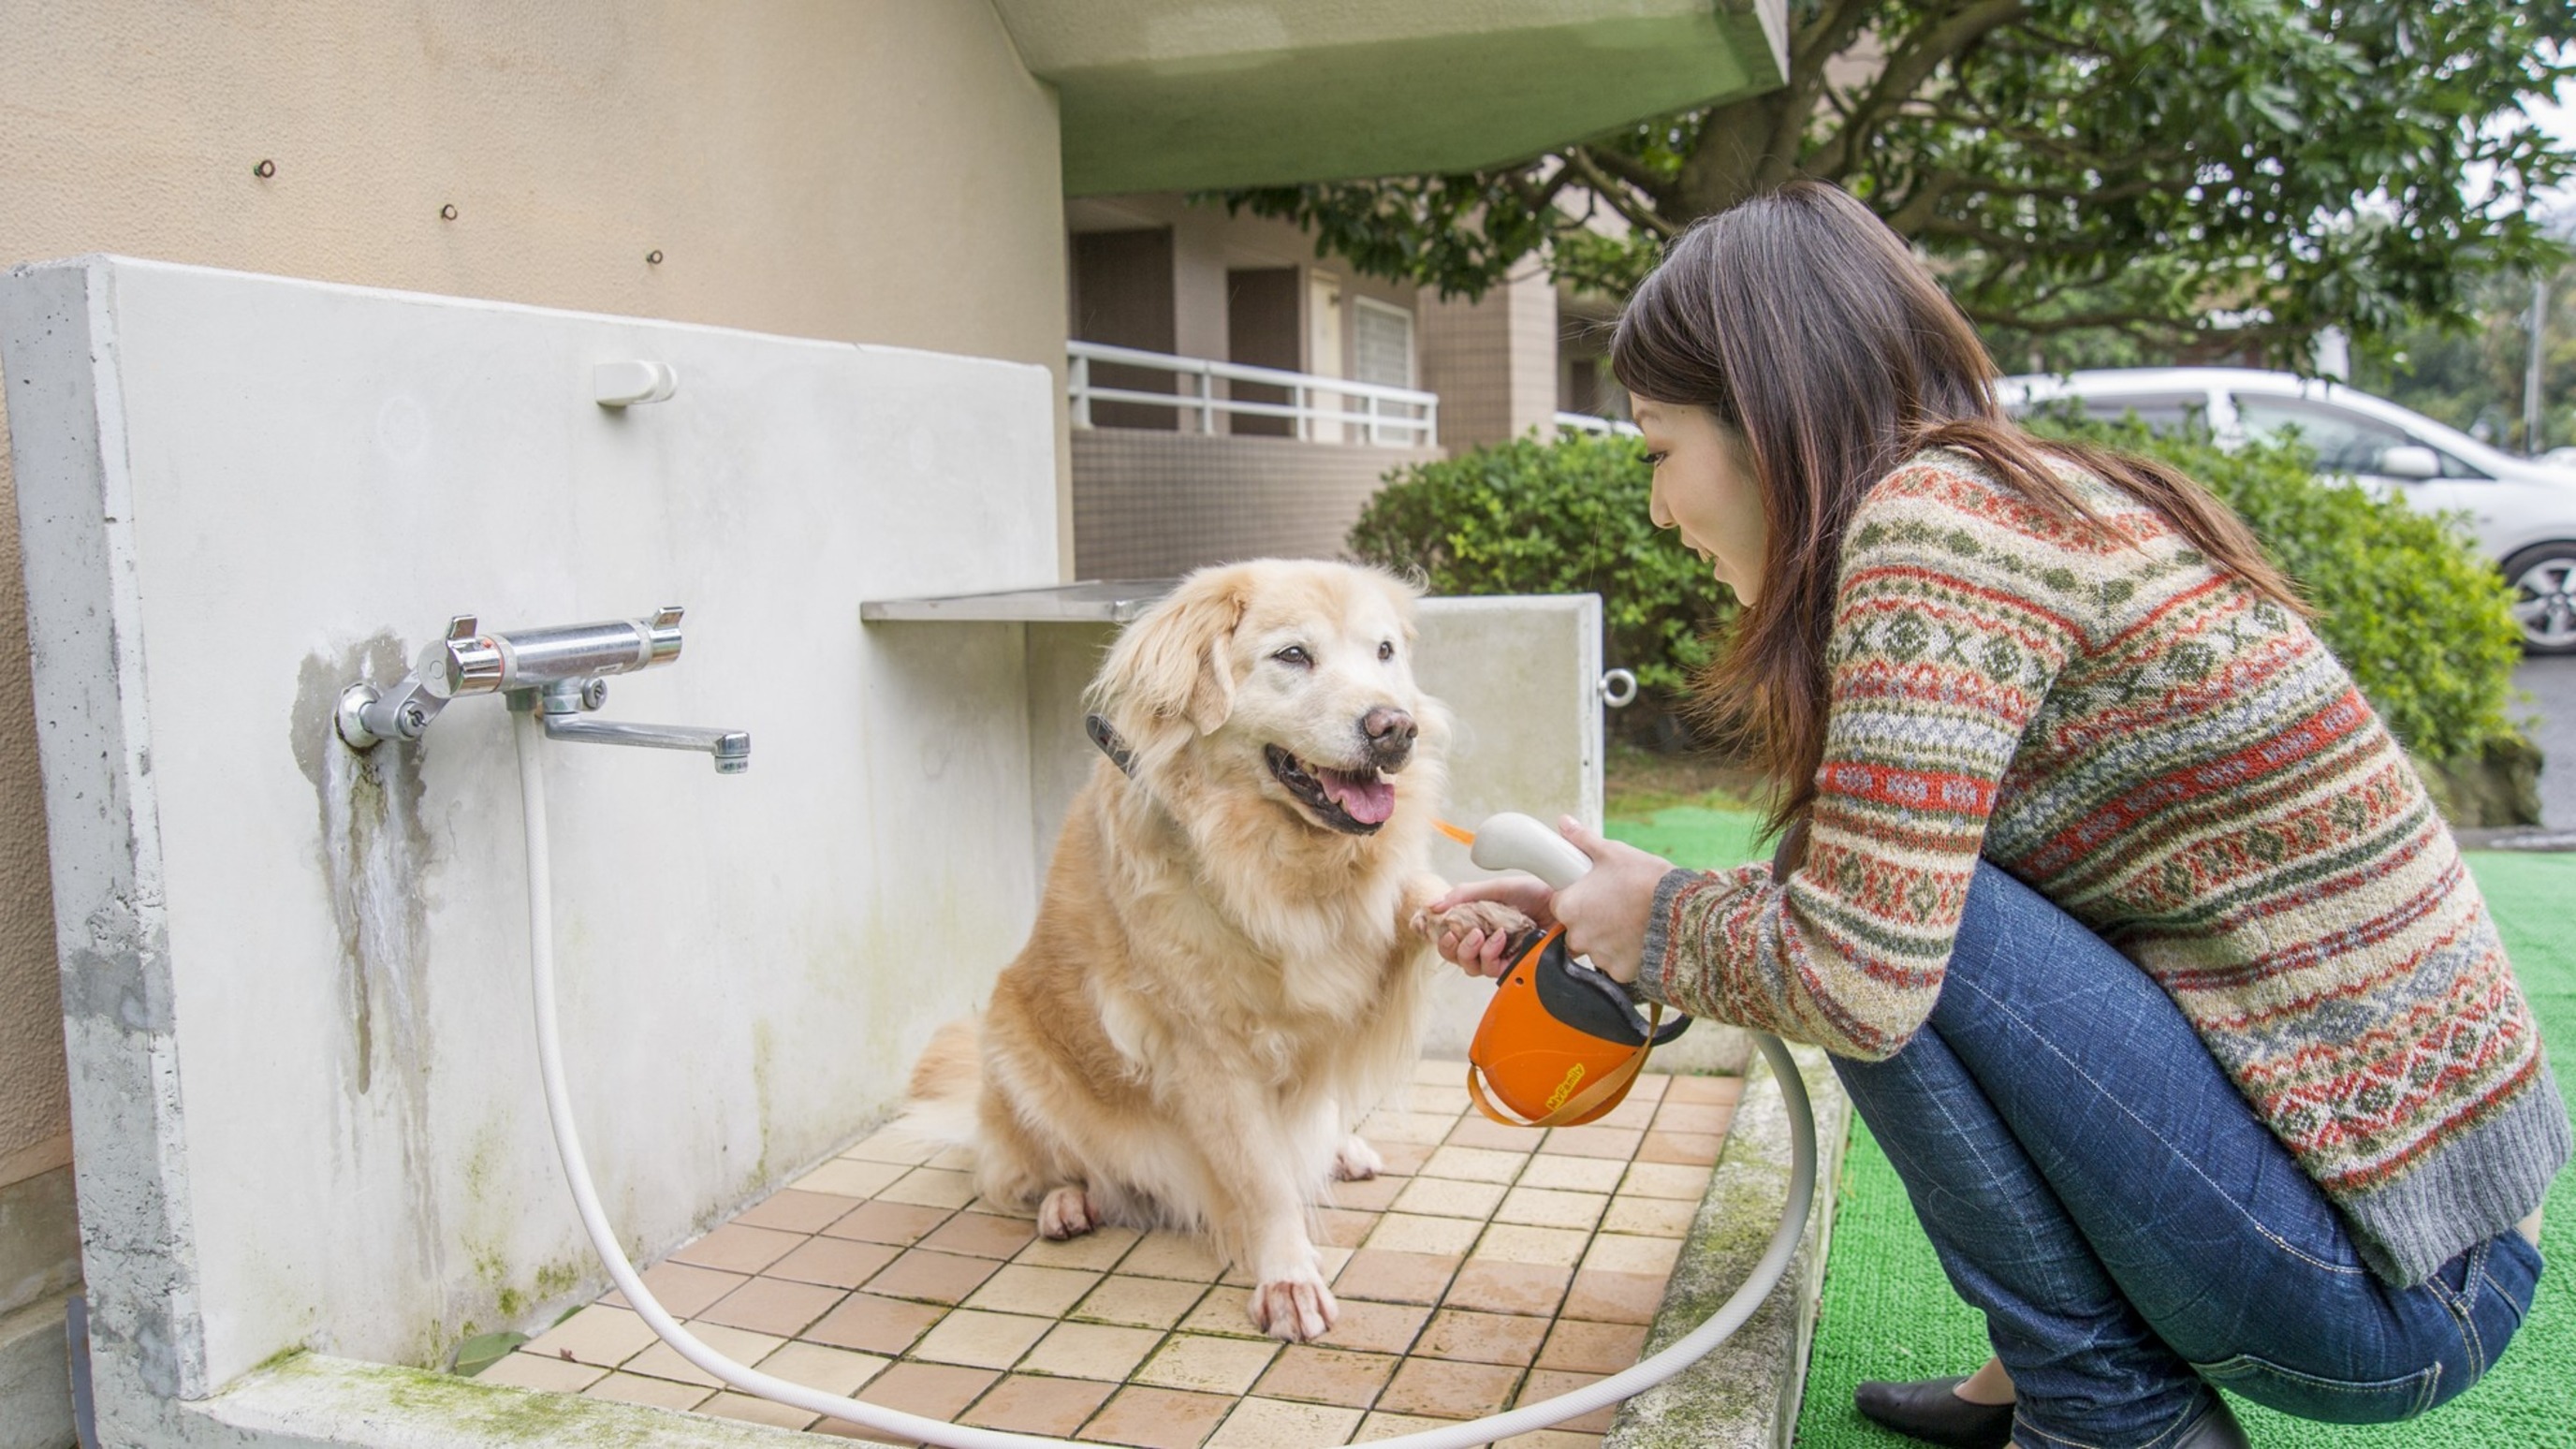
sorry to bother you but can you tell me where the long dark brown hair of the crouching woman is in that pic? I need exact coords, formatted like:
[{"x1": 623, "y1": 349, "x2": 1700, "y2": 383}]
[{"x1": 1610, "y1": 181, "x2": 2305, "y2": 830}]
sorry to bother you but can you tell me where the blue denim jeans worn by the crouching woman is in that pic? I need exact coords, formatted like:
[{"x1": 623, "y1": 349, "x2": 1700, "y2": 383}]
[{"x1": 1834, "y1": 864, "x2": 2539, "y2": 1449}]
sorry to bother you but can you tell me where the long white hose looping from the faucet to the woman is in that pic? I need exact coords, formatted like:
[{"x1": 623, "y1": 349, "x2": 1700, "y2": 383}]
[{"x1": 513, "y1": 711, "x2": 1816, "y2": 1449}]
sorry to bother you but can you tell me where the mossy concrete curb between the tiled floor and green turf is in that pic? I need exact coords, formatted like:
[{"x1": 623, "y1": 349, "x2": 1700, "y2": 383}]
[{"x1": 1604, "y1": 1046, "x2": 1852, "y2": 1449}]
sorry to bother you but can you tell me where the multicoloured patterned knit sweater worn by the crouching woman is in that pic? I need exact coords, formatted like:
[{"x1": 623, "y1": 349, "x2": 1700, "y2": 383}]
[{"x1": 1641, "y1": 451, "x2": 2569, "y2": 1284}]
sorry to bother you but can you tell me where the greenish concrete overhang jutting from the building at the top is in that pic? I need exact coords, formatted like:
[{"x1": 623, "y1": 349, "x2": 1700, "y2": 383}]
[{"x1": 994, "y1": 0, "x2": 1788, "y2": 196}]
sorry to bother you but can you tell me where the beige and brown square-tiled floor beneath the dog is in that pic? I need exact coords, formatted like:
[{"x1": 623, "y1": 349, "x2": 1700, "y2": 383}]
[{"x1": 482, "y1": 1046, "x2": 1741, "y2": 1449}]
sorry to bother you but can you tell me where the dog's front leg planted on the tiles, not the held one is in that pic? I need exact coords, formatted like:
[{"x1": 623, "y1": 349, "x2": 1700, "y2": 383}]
[{"x1": 1182, "y1": 1090, "x2": 1342, "y2": 1343}]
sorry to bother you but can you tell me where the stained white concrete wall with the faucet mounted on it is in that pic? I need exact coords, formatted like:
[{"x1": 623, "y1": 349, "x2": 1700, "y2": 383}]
[{"x1": 0, "y1": 260, "x2": 1056, "y2": 1439}]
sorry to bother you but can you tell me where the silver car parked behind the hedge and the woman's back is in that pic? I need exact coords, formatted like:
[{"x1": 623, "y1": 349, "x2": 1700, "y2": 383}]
[{"x1": 2001, "y1": 366, "x2": 2576, "y2": 655}]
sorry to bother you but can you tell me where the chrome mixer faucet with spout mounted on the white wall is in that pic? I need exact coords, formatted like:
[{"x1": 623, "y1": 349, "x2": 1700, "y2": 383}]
[{"x1": 338, "y1": 604, "x2": 753, "y2": 776}]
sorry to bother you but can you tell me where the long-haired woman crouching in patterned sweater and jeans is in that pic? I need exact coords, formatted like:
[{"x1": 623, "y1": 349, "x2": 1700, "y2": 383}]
[{"x1": 1442, "y1": 183, "x2": 2569, "y2": 1449}]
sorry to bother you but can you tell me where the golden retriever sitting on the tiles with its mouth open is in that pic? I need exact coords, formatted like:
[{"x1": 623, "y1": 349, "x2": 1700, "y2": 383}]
[{"x1": 907, "y1": 560, "x2": 1481, "y2": 1340}]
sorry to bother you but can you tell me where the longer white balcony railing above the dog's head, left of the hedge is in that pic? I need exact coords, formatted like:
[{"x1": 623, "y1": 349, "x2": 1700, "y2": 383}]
[{"x1": 1064, "y1": 341, "x2": 1440, "y2": 448}]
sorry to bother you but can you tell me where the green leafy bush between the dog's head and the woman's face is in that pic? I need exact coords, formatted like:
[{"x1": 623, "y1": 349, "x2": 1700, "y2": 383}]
[{"x1": 1350, "y1": 433, "x2": 1736, "y2": 694}]
